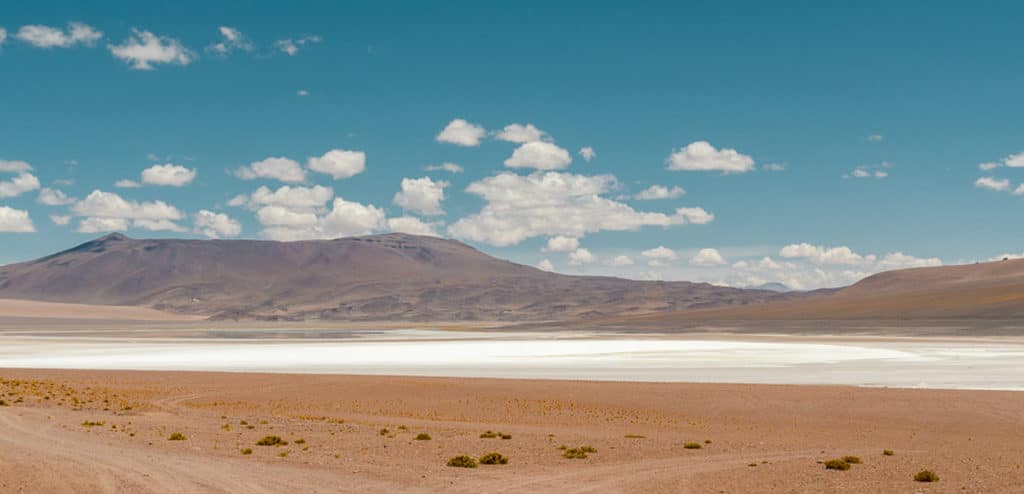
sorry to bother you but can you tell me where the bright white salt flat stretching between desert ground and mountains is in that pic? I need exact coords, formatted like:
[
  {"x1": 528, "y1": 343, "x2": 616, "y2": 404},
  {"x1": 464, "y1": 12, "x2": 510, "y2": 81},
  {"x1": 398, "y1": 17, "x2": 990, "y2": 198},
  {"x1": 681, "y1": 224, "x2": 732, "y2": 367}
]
[{"x1": 0, "y1": 331, "x2": 1024, "y2": 390}]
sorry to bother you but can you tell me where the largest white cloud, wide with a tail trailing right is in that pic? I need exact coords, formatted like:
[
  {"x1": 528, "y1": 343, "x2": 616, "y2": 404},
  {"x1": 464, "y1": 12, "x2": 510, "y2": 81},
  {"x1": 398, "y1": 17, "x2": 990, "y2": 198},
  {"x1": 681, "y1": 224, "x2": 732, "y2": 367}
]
[{"x1": 449, "y1": 172, "x2": 714, "y2": 246}]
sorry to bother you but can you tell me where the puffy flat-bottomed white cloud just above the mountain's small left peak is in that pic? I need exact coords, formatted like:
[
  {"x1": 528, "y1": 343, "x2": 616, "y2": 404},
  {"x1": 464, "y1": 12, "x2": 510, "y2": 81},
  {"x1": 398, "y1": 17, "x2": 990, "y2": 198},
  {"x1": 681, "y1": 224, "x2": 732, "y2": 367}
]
[{"x1": 71, "y1": 190, "x2": 184, "y2": 233}]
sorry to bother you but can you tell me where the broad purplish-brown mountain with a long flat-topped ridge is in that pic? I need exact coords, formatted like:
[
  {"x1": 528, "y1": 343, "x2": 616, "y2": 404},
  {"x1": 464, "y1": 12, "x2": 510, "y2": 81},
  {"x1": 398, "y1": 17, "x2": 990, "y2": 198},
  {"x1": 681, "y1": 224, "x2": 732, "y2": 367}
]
[{"x1": 0, "y1": 234, "x2": 795, "y2": 321}]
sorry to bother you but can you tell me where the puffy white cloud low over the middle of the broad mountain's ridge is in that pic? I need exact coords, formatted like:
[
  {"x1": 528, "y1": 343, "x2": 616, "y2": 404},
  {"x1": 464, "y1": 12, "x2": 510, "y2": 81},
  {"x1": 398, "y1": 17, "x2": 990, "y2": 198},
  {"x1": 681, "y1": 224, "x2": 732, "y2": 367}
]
[{"x1": 256, "y1": 198, "x2": 387, "y2": 240}]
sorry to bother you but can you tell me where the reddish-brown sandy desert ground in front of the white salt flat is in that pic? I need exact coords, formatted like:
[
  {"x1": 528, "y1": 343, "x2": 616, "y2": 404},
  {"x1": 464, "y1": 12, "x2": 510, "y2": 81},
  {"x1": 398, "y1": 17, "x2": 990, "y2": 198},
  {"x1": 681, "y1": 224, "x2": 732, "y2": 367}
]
[{"x1": 0, "y1": 370, "x2": 1024, "y2": 493}]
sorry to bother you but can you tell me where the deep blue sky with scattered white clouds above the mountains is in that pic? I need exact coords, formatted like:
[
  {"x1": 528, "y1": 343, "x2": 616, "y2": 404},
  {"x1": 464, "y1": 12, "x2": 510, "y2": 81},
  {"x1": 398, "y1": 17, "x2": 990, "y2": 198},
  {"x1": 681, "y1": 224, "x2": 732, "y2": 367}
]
[{"x1": 0, "y1": 1, "x2": 1024, "y2": 289}]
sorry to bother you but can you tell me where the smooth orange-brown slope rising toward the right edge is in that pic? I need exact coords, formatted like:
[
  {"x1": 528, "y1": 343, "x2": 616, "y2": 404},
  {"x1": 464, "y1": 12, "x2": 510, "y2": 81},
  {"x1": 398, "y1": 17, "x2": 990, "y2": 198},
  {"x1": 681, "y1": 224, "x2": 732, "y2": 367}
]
[{"x1": 618, "y1": 259, "x2": 1024, "y2": 326}]
